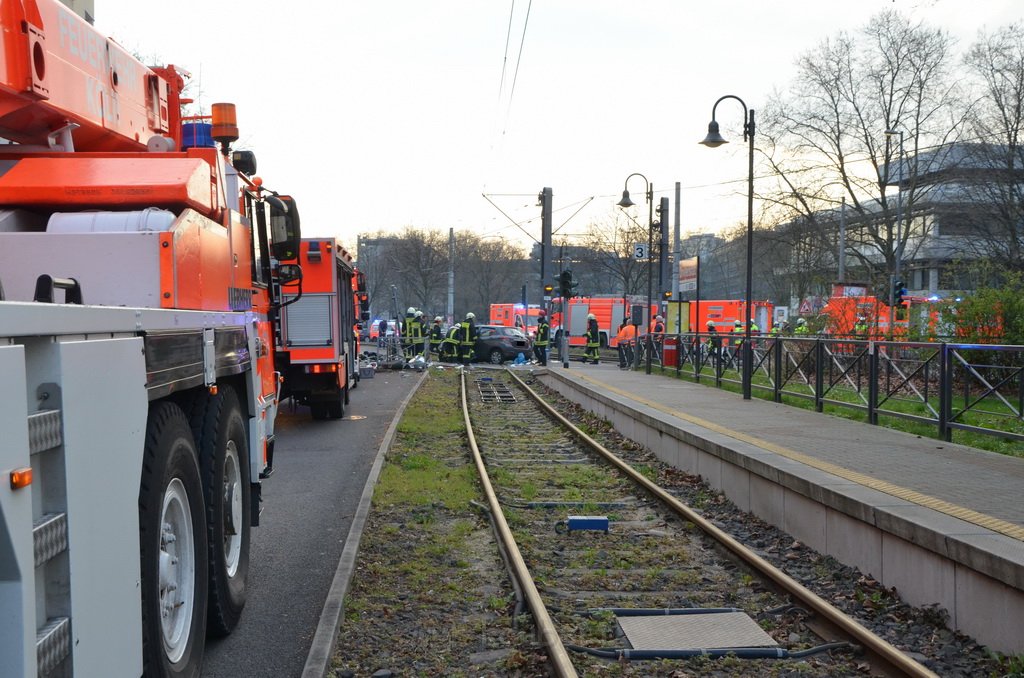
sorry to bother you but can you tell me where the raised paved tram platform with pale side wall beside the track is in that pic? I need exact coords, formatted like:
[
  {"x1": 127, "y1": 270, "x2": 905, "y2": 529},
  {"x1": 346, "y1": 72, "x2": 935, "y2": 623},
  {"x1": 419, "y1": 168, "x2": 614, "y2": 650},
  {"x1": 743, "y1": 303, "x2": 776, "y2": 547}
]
[{"x1": 537, "y1": 363, "x2": 1024, "y2": 653}]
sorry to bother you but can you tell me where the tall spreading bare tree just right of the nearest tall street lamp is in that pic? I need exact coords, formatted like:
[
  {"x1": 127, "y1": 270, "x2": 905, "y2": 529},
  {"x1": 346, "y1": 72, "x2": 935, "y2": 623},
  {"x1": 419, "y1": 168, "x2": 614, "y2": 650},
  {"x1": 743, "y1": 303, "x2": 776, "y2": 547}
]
[{"x1": 760, "y1": 10, "x2": 962, "y2": 288}]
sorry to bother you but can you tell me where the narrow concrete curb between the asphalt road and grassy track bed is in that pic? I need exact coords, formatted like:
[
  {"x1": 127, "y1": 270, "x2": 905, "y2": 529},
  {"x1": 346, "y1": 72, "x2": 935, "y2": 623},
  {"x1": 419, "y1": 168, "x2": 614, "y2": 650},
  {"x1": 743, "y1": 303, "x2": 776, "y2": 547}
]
[{"x1": 302, "y1": 371, "x2": 429, "y2": 678}]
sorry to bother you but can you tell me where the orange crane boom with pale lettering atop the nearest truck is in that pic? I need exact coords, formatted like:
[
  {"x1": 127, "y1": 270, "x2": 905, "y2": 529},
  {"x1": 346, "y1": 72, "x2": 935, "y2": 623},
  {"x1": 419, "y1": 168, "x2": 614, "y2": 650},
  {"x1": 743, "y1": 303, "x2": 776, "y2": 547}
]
[{"x1": 0, "y1": 0, "x2": 184, "y2": 152}]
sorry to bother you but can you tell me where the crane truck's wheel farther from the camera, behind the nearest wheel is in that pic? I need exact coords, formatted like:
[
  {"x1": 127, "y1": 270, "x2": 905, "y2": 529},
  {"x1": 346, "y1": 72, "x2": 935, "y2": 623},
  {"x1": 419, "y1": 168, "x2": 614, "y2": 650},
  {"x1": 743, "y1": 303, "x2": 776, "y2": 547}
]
[{"x1": 191, "y1": 386, "x2": 250, "y2": 636}]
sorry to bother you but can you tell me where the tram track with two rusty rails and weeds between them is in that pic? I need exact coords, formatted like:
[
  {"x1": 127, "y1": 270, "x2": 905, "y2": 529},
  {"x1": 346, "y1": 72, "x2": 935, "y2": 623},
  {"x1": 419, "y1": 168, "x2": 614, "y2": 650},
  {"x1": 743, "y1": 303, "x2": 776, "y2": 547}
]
[{"x1": 462, "y1": 372, "x2": 936, "y2": 676}]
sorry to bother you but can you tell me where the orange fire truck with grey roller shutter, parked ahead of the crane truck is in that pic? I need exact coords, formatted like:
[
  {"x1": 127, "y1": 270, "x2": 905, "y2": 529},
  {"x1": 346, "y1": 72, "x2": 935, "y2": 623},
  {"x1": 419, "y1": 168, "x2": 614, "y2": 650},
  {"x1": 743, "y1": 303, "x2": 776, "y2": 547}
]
[{"x1": 276, "y1": 238, "x2": 367, "y2": 419}]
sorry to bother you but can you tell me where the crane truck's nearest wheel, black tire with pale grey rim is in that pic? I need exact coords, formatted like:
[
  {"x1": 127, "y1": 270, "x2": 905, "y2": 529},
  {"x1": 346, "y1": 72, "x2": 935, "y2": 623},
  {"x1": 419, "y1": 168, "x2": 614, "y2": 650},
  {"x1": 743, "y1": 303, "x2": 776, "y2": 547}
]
[{"x1": 138, "y1": 401, "x2": 208, "y2": 678}]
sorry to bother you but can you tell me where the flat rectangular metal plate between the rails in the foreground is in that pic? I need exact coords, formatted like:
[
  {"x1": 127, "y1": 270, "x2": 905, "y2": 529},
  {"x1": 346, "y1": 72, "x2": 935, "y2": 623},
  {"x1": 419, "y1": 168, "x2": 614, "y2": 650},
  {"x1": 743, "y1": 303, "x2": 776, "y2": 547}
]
[{"x1": 615, "y1": 612, "x2": 778, "y2": 649}]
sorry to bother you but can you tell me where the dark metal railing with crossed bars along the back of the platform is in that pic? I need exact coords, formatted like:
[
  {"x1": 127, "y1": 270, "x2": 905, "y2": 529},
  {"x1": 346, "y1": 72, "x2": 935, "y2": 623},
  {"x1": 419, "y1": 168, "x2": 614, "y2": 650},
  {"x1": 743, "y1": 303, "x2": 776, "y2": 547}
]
[{"x1": 622, "y1": 333, "x2": 1024, "y2": 441}]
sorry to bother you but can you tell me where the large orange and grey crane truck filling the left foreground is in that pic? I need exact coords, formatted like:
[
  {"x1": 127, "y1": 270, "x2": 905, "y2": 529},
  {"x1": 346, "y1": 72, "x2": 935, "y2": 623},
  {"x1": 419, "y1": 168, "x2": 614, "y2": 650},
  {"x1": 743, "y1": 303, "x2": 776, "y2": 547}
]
[{"x1": 0, "y1": 0, "x2": 301, "y2": 677}]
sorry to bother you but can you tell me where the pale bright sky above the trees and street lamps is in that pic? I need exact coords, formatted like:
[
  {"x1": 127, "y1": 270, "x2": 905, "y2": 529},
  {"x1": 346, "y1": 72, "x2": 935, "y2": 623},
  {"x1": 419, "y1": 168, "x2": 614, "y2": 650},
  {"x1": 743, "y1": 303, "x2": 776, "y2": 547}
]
[{"x1": 95, "y1": 0, "x2": 1024, "y2": 255}]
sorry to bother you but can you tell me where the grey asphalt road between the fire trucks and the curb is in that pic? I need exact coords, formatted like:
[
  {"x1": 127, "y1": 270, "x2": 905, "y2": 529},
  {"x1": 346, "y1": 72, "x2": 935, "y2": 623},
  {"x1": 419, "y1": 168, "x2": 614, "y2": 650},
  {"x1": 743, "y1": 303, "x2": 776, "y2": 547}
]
[{"x1": 203, "y1": 371, "x2": 420, "y2": 678}]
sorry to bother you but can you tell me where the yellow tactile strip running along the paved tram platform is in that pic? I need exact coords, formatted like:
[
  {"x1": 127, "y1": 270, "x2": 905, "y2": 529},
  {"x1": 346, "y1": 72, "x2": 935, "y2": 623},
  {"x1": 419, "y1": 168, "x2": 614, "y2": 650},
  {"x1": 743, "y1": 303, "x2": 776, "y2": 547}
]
[{"x1": 580, "y1": 375, "x2": 1024, "y2": 541}]
